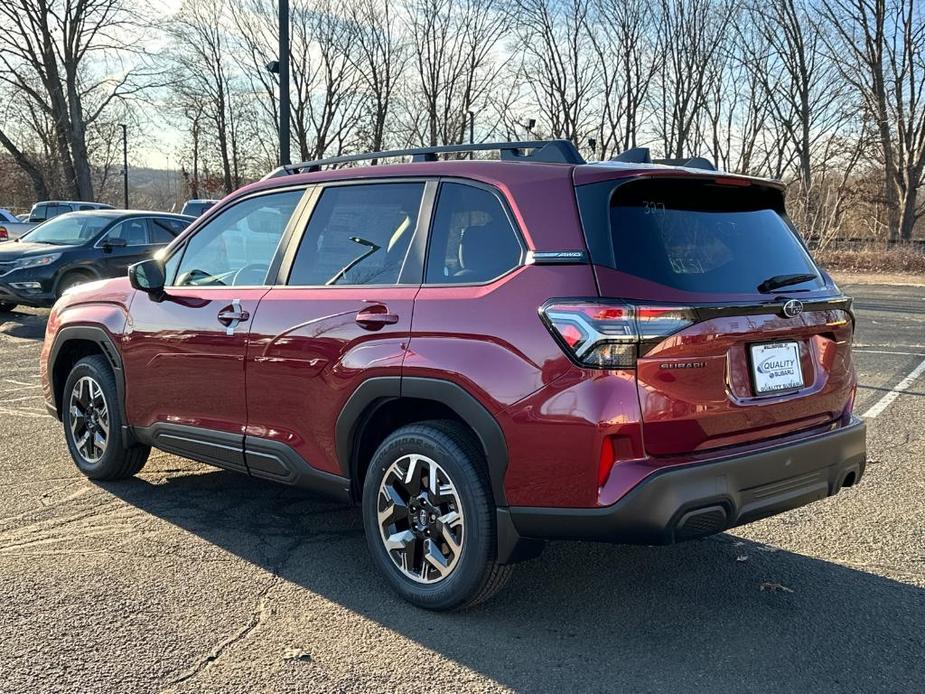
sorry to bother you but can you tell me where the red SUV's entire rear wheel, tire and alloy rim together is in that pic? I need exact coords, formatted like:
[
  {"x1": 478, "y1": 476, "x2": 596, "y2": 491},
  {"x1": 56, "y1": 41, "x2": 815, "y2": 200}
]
[{"x1": 363, "y1": 420, "x2": 510, "y2": 610}]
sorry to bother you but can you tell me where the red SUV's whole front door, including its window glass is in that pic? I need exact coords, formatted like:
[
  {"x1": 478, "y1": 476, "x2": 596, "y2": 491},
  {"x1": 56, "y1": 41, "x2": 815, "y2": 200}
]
[{"x1": 124, "y1": 189, "x2": 304, "y2": 438}]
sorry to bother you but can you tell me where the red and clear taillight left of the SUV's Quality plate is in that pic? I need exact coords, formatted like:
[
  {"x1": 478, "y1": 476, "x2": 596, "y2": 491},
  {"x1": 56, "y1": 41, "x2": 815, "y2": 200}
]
[{"x1": 540, "y1": 299, "x2": 694, "y2": 369}]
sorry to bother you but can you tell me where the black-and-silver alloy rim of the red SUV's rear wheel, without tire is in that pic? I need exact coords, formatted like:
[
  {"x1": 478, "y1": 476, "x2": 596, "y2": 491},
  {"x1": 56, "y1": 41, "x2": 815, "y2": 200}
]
[{"x1": 377, "y1": 454, "x2": 465, "y2": 583}]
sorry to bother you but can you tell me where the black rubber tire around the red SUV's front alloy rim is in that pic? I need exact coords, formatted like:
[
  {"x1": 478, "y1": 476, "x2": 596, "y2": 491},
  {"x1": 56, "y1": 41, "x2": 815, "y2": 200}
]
[{"x1": 61, "y1": 355, "x2": 151, "y2": 480}]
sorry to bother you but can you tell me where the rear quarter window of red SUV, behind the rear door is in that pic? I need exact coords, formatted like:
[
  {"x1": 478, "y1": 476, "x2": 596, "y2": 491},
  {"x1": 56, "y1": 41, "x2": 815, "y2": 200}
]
[{"x1": 425, "y1": 183, "x2": 523, "y2": 284}]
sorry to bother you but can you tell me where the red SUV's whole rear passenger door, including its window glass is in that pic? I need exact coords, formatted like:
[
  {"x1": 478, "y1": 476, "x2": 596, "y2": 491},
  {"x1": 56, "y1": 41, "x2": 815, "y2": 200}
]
[{"x1": 240, "y1": 180, "x2": 424, "y2": 474}]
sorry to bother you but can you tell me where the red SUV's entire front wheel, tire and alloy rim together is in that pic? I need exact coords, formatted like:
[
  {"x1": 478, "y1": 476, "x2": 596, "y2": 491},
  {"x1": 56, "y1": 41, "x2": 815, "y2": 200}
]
[{"x1": 61, "y1": 355, "x2": 151, "y2": 480}]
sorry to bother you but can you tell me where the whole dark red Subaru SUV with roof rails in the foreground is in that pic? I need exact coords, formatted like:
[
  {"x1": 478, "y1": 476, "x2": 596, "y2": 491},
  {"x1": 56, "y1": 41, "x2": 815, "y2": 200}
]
[{"x1": 41, "y1": 141, "x2": 865, "y2": 609}]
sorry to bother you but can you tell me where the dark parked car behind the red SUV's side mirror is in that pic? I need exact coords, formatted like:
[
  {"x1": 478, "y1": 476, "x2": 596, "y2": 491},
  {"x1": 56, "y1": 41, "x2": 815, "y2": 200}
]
[{"x1": 0, "y1": 210, "x2": 192, "y2": 311}]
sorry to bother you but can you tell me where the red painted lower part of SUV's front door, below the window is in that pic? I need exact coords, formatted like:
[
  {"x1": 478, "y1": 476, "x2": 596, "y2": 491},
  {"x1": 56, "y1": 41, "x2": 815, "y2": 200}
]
[{"x1": 123, "y1": 287, "x2": 267, "y2": 435}]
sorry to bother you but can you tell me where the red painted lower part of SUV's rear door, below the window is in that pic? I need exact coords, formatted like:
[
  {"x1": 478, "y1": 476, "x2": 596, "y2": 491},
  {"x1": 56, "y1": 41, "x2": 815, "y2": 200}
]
[{"x1": 246, "y1": 287, "x2": 418, "y2": 474}]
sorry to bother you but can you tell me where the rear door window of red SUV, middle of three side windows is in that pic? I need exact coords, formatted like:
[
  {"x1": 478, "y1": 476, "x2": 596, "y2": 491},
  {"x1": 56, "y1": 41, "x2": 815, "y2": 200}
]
[{"x1": 289, "y1": 183, "x2": 424, "y2": 287}]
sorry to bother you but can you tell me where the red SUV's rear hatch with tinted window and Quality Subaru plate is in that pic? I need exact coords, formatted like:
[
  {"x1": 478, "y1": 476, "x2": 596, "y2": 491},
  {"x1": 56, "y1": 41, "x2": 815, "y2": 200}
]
[{"x1": 577, "y1": 176, "x2": 855, "y2": 455}]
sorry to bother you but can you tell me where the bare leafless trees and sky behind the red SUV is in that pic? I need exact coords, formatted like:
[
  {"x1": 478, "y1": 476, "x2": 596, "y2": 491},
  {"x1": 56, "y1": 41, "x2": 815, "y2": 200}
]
[{"x1": 0, "y1": 0, "x2": 925, "y2": 249}]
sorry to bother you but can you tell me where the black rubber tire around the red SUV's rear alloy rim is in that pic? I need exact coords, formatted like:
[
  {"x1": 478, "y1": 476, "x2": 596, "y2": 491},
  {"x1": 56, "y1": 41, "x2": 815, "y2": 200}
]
[{"x1": 362, "y1": 420, "x2": 511, "y2": 610}]
